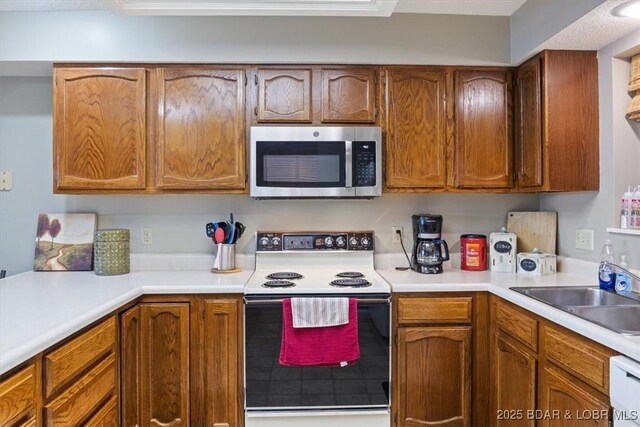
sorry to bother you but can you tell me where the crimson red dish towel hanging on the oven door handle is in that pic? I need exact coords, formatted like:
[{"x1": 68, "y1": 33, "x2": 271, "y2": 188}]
[{"x1": 280, "y1": 298, "x2": 360, "y2": 366}]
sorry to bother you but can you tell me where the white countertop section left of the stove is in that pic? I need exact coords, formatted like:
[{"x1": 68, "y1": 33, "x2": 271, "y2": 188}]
[{"x1": 0, "y1": 269, "x2": 253, "y2": 374}]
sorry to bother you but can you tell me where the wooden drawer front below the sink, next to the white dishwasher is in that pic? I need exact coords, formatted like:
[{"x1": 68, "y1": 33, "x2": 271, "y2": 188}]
[{"x1": 544, "y1": 326, "x2": 613, "y2": 395}]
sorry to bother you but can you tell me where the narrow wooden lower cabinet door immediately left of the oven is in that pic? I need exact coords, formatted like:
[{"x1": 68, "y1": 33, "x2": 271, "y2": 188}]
[{"x1": 204, "y1": 299, "x2": 242, "y2": 427}]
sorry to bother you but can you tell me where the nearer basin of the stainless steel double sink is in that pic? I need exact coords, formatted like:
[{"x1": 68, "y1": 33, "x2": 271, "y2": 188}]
[{"x1": 567, "y1": 305, "x2": 640, "y2": 335}]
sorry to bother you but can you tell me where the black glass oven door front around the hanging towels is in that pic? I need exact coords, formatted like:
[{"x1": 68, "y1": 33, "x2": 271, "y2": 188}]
[{"x1": 245, "y1": 304, "x2": 390, "y2": 410}]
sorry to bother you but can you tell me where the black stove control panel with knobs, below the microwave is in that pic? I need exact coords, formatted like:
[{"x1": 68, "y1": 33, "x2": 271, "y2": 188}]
[{"x1": 256, "y1": 231, "x2": 374, "y2": 252}]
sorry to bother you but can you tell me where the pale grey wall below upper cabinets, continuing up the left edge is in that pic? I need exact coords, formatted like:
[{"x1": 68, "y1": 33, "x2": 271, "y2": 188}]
[{"x1": 0, "y1": 77, "x2": 539, "y2": 274}]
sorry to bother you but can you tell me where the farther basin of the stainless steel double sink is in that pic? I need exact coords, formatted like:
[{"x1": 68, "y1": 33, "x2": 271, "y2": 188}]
[{"x1": 511, "y1": 286, "x2": 640, "y2": 307}]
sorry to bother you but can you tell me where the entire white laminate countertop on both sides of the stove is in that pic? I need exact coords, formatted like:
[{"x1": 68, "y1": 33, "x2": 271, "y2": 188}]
[{"x1": 0, "y1": 268, "x2": 640, "y2": 374}]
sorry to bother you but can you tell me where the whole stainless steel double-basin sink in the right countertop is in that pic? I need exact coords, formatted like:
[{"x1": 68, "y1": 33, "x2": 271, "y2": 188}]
[{"x1": 511, "y1": 286, "x2": 640, "y2": 335}]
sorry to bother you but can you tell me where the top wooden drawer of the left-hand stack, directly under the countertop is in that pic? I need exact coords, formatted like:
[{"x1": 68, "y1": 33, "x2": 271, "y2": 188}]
[{"x1": 43, "y1": 317, "x2": 116, "y2": 398}]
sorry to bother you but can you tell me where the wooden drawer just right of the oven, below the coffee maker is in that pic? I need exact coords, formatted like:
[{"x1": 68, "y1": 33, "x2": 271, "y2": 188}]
[{"x1": 398, "y1": 297, "x2": 473, "y2": 324}]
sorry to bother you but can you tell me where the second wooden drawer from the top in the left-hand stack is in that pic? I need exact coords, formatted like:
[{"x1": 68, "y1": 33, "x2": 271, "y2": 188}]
[{"x1": 44, "y1": 354, "x2": 116, "y2": 427}]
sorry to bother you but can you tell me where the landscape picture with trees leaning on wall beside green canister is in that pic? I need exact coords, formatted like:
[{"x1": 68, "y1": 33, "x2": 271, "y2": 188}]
[{"x1": 33, "y1": 213, "x2": 98, "y2": 271}]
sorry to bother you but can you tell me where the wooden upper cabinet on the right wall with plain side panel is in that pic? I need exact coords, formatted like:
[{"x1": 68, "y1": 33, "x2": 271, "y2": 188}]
[{"x1": 516, "y1": 51, "x2": 599, "y2": 192}]
